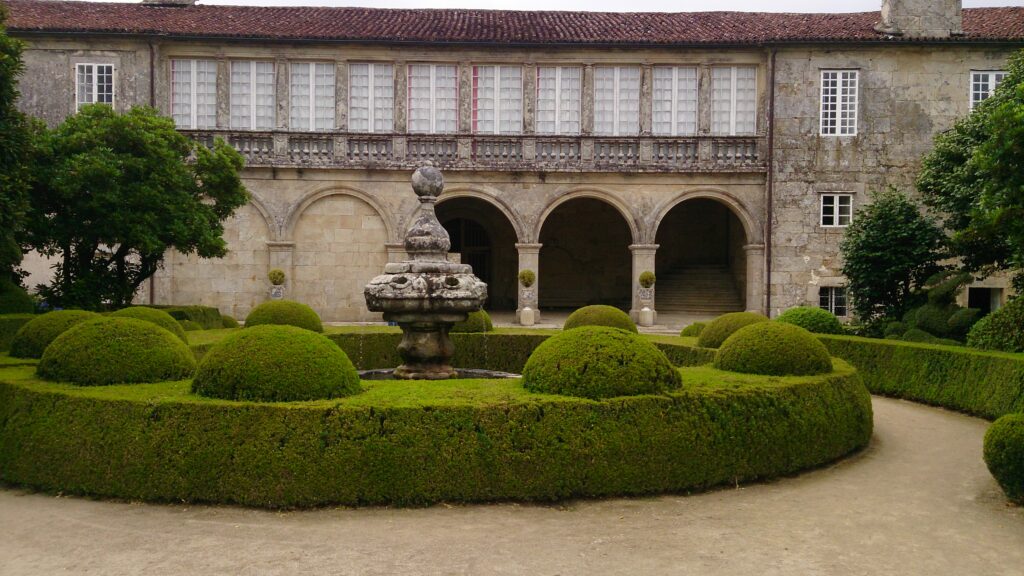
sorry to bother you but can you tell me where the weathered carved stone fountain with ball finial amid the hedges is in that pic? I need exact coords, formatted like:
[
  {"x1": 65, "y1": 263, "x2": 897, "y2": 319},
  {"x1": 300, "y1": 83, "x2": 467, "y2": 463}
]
[{"x1": 364, "y1": 166, "x2": 487, "y2": 380}]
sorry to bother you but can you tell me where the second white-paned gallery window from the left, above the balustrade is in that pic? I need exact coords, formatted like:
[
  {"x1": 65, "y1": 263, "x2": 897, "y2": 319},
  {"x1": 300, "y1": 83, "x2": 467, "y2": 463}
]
[{"x1": 230, "y1": 60, "x2": 276, "y2": 130}]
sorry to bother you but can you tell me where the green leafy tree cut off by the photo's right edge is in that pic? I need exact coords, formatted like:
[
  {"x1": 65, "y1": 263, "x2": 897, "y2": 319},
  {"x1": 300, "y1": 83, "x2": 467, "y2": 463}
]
[{"x1": 918, "y1": 51, "x2": 1024, "y2": 288}]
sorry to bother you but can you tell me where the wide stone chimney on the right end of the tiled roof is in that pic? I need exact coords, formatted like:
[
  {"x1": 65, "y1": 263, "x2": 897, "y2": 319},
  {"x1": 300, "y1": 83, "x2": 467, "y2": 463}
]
[{"x1": 874, "y1": 0, "x2": 964, "y2": 38}]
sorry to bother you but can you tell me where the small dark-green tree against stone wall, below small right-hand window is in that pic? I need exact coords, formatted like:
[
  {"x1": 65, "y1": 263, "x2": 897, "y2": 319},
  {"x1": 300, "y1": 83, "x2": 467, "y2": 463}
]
[{"x1": 840, "y1": 190, "x2": 945, "y2": 323}]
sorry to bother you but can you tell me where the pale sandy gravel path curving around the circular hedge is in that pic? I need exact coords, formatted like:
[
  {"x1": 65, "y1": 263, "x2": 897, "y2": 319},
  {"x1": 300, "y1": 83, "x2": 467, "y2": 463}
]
[{"x1": 0, "y1": 398, "x2": 1024, "y2": 576}]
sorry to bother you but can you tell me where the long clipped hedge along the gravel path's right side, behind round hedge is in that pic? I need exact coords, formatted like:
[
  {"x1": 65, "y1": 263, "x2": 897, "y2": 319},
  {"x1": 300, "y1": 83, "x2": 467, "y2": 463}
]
[{"x1": 817, "y1": 334, "x2": 1024, "y2": 420}]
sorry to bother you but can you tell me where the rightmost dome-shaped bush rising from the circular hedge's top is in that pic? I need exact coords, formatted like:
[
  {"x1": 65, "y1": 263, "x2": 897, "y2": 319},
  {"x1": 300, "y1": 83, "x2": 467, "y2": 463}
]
[{"x1": 715, "y1": 322, "x2": 831, "y2": 376}]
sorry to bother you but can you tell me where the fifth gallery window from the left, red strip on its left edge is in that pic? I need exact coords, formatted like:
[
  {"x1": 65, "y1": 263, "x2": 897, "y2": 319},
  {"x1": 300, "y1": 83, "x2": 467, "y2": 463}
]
[{"x1": 409, "y1": 64, "x2": 459, "y2": 133}]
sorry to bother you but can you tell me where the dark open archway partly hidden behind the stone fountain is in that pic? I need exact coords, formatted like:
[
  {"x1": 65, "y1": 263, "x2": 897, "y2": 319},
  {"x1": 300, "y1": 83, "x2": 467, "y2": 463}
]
[{"x1": 435, "y1": 197, "x2": 519, "y2": 310}]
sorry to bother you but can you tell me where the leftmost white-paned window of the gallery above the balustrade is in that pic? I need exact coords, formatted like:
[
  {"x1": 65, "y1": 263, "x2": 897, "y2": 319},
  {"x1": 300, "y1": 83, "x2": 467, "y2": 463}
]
[{"x1": 171, "y1": 58, "x2": 217, "y2": 129}]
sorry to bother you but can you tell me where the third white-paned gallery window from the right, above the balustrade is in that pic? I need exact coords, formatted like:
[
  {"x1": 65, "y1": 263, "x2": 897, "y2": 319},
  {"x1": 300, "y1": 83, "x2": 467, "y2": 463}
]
[{"x1": 594, "y1": 66, "x2": 640, "y2": 136}]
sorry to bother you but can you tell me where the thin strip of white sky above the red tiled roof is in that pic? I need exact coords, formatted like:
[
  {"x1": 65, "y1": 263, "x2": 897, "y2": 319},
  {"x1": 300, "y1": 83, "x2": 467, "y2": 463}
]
[{"x1": 86, "y1": 0, "x2": 1024, "y2": 12}]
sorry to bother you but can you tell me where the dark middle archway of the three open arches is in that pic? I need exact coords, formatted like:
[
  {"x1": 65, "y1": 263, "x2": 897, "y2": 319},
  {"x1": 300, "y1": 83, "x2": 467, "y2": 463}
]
[{"x1": 538, "y1": 198, "x2": 633, "y2": 311}]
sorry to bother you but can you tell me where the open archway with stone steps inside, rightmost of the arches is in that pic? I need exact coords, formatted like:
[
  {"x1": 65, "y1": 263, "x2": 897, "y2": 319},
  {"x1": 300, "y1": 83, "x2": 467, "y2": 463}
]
[{"x1": 654, "y1": 198, "x2": 746, "y2": 317}]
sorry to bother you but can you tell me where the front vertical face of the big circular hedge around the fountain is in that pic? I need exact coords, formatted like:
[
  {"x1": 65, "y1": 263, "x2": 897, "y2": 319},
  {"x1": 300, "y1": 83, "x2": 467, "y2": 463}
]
[{"x1": 0, "y1": 366, "x2": 872, "y2": 507}]
